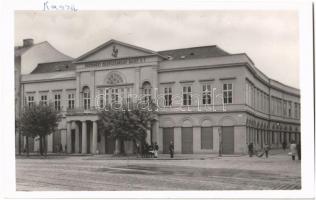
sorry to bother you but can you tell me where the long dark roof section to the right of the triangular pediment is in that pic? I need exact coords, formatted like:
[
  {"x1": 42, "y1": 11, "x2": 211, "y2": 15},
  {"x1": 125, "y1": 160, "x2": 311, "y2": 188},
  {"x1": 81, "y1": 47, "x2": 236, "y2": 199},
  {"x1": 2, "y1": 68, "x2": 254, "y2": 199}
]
[{"x1": 158, "y1": 45, "x2": 230, "y2": 60}]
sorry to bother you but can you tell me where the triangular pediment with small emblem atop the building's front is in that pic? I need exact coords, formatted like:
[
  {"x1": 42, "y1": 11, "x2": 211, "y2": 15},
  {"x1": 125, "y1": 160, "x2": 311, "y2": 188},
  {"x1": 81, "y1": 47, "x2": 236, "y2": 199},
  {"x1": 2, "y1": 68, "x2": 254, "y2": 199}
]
[{"x1": 75, "y1": 40, "x2": 158, "y2": 62}]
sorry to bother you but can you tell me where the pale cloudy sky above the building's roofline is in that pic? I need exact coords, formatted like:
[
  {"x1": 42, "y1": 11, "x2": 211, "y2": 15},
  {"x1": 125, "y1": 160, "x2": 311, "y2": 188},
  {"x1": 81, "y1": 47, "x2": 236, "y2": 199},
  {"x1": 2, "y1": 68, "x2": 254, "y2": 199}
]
[{"x1": 15, "y1": 10, "x2": 299, "y2": 88}]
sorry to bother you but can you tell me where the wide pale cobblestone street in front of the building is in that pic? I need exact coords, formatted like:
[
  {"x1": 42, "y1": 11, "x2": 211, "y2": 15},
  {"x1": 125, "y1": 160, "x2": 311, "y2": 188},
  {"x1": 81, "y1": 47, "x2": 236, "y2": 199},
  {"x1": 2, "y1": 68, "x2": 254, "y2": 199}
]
[{"x1": 16, "y1": 153, "x2": 301, "y2": 191}]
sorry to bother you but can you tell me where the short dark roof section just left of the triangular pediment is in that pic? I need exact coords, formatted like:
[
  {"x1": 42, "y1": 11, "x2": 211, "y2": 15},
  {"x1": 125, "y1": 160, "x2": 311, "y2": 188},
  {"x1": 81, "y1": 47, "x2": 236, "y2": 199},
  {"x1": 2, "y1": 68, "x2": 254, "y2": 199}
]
[{"x1": 31, "y1": 60, "x2": 75, "y2": 74}]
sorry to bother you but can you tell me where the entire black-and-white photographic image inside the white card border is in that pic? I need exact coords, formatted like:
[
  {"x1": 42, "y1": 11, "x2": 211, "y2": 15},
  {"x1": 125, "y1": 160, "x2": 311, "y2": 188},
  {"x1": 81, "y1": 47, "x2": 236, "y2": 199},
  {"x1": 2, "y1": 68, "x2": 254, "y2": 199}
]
[{"x1": 1, "y1": 1, "x2": 314, "y2": 198}]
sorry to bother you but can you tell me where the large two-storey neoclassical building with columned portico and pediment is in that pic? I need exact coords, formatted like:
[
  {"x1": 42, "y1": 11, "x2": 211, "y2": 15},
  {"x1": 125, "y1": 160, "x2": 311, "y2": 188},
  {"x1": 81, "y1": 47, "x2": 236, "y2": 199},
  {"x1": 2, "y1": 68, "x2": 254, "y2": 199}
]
[{"x1": 20, "y1": 40, "x2": 300, "y2": 154}]
